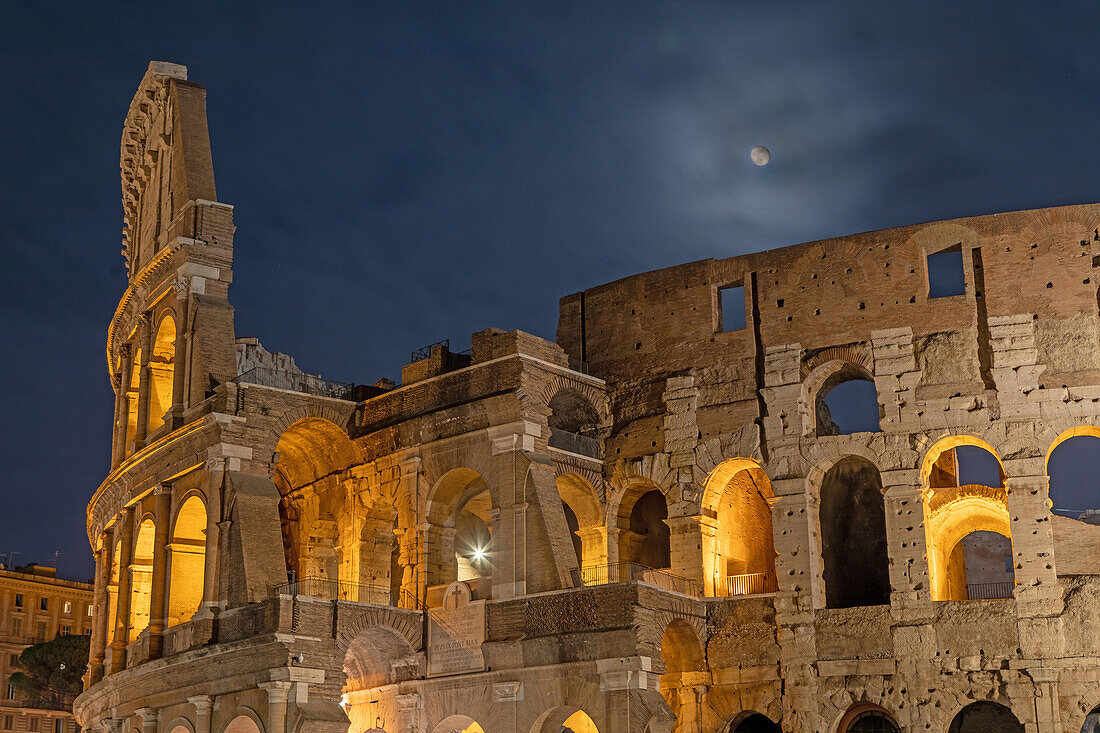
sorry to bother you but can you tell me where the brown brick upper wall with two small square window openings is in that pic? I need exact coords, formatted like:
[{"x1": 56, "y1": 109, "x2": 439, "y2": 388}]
[{"x1": 558, "y1": 205, "x2": 1100, "y2": 402}]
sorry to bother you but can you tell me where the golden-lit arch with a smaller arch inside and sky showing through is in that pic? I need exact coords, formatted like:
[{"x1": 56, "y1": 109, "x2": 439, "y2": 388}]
[{"x1": 924, "y1": 436, "x2": 1015, "y2": 601}]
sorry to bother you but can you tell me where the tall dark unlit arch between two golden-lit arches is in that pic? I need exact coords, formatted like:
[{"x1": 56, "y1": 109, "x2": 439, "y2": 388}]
[{"x1": 820, "y1": 456, "x2": 890, "y2": 609}]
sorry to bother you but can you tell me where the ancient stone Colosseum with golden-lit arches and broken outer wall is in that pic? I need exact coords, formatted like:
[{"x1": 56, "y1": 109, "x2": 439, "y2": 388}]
[{"x1": 75, "y1": 62, "x2": 1100, "y2": 733}]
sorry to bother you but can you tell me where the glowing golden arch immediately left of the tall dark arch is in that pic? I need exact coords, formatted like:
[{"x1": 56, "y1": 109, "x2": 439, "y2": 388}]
[{"x1": 703, "y1": 459, "x2": 778, "y2": 595}]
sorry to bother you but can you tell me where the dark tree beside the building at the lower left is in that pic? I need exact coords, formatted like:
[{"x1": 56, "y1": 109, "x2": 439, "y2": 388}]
[{"x1": 9, "y1": 635, "x2": 91, "y2": 708}]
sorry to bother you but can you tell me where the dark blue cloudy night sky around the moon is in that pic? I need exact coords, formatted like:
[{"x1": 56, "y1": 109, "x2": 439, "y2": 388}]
[{"x1": 0, "y1": 0, "x2": 1100, "y2": 578}]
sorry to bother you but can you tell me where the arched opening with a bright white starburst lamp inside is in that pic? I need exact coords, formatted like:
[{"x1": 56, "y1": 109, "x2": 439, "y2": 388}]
[{"x1": 425, "y1": 468, "x2": 493, "y2": 586}]
